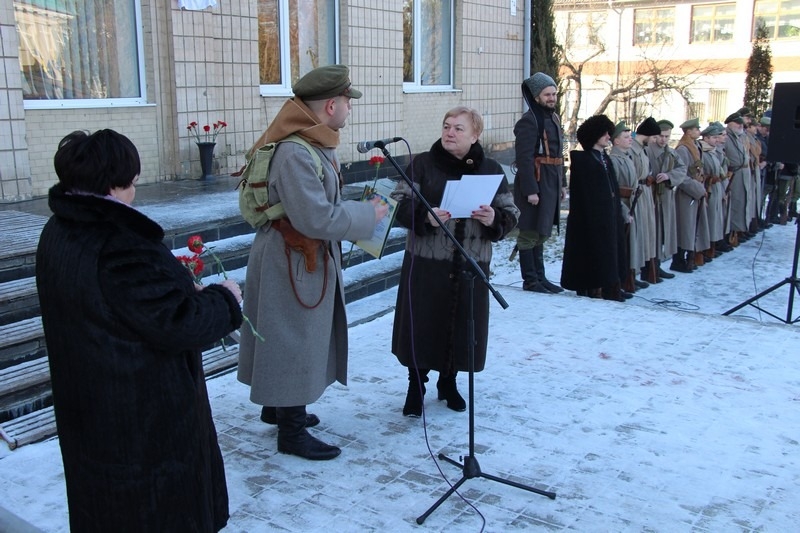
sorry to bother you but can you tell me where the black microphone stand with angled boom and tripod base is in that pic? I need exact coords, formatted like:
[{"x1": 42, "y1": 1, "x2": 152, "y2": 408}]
[{"x1": 375, "y1": 143, "x2": 556, "y2": 524}]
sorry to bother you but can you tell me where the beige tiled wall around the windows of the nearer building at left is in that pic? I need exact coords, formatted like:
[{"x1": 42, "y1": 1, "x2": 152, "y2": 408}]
[{"x1": 0, "y1": 0, "x2": 524, "y2": 202}]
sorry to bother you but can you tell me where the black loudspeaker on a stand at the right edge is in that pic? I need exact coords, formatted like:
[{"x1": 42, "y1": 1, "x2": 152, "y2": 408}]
[{"x1": 767, "y1": 83, "x2": 800, "y2": 163}]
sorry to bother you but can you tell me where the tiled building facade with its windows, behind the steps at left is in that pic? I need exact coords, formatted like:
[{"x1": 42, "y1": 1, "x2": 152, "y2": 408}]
[{"x1": 0, "y1": 0, "x2": 530, "y2": 202}]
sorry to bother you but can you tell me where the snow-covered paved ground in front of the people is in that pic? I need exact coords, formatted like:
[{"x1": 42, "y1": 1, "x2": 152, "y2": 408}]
[{"x1": 0, "y1": 218, "x2": 800, "y2": 533}]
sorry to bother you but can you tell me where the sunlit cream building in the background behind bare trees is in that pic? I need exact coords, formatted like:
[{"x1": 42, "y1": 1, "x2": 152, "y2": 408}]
[{"x1": 555, "y1": 0, "x2": 800, "y2": 132}]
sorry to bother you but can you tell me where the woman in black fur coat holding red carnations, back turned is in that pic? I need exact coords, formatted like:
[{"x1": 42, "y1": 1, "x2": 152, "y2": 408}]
[{"x1": 36, "y1": 130, "x2": 242, "y2": 533}]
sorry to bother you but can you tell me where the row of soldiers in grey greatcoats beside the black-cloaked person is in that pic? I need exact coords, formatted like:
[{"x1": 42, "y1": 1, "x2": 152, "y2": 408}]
[{"x1": 610, "y1": 108, "x2": 788, "y2": 293}]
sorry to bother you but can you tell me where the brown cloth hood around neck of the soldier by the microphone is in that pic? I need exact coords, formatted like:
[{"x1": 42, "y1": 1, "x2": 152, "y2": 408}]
[{"x1": 247, "y1": 98, "x2": 339, "y2": 157}]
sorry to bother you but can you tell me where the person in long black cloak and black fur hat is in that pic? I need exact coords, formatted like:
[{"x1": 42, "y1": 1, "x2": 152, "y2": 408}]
[{"x1": 561, "y1": 115, "x2": 626, "y2": 301}]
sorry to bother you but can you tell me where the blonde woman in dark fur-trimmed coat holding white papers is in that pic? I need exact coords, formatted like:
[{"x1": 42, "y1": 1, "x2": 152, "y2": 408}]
[{"x1": 392, "y1": 107, "x2": 519, "y2": 417}]
